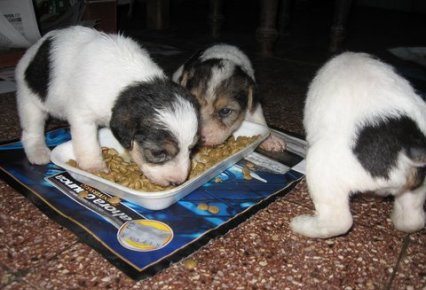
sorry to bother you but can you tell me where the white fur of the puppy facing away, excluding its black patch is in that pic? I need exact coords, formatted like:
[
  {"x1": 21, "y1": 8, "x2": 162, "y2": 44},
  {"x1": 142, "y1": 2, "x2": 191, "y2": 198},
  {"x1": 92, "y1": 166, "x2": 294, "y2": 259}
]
[{"x1": 291, "y1": 52, "x2": 426, "y2": 238}]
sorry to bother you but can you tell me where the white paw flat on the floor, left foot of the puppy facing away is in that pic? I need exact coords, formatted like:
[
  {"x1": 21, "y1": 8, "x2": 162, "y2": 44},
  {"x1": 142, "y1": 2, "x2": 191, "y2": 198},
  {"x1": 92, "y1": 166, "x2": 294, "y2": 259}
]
[{"x1": 290, "y1": 215, "x2": 352, "y2": 239}]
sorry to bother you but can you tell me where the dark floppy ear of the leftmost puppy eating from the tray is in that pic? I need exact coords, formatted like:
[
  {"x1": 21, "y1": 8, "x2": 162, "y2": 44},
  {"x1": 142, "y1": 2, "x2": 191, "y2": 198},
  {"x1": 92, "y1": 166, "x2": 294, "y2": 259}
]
[{"x1": 109, "y1": 106, "x2": 136, "y2": 149}]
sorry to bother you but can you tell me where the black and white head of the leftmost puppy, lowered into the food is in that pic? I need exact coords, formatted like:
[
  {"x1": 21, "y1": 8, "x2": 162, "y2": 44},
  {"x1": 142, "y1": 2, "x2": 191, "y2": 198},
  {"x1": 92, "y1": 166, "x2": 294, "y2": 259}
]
[{"x1": 110, "y1": 79, "x2": 199, "y2": 186}]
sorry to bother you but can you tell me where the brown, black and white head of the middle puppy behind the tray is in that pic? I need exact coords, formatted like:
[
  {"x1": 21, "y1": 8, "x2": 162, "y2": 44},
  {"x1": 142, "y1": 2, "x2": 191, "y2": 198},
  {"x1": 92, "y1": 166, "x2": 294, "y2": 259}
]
[{"x1": 177, "y1": 59, "x2": 257, "y2": 146}]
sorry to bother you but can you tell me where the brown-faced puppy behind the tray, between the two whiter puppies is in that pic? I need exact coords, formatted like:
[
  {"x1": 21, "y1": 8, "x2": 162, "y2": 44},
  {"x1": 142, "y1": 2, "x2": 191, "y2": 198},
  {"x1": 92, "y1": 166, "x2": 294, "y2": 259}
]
[{"x1": 173, "y1": 44, "x2": 285, "y2": 151}]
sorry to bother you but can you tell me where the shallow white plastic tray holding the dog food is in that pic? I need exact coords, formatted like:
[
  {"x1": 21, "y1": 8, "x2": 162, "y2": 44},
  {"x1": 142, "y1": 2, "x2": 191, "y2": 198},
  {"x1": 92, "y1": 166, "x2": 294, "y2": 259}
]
[{"x1": 50, "y1": 121, "x2": 270, "y2": 210}]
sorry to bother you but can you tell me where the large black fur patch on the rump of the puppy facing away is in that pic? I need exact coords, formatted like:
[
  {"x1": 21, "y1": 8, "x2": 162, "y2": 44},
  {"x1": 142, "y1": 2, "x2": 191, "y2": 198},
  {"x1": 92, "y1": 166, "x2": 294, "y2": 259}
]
[{"x1": 353, "y1": 116, "x2": 426, "y2": 179}]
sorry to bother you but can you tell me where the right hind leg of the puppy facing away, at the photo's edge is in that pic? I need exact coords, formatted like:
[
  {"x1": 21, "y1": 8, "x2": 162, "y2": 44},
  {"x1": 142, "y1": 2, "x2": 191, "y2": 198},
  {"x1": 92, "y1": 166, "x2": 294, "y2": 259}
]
[{"x1": 391, "y1": 179, "x2": 426, "y2": 233}]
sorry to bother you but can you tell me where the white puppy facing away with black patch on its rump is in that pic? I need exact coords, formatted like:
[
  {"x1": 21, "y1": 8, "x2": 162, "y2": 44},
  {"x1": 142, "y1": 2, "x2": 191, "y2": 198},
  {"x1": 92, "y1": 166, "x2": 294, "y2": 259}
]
[{"x1": 291, "y1": 52, "x2": 426, "y2": 238}]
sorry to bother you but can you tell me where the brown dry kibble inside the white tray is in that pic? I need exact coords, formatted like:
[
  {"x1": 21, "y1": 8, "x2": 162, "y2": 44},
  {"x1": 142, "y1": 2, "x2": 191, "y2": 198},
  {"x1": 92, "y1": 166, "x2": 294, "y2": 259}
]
[{"x1": 67, "y1": 136, "x2": 259, "y2": 192}]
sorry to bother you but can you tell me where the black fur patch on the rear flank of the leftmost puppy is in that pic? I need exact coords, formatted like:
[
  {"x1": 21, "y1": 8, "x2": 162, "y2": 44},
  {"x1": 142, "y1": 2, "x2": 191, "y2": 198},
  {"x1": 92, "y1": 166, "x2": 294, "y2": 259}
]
[{"x1": 25, "y1": 38, "x2": 52, "y2": 102}]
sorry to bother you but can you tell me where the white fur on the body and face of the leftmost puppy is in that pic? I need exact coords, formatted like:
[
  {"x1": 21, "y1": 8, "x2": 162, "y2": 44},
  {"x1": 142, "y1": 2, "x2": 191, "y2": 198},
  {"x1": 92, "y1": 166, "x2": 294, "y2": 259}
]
[{"x1": 16, "y1": 26, "x2": 197, "y2": 186}]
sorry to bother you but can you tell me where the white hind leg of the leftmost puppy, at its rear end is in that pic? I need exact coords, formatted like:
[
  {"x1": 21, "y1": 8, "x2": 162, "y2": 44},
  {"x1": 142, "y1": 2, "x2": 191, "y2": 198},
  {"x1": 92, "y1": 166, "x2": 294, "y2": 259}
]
[{"x1": 18, "y1": 98, "x2": 50, "y2": 165}]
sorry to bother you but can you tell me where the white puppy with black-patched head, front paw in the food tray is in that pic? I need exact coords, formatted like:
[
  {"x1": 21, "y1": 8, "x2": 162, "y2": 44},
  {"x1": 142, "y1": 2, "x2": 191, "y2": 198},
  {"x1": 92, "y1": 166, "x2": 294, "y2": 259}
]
[{"x1": 16, "y1": 26, "x2": 199, "y2": 185}]
